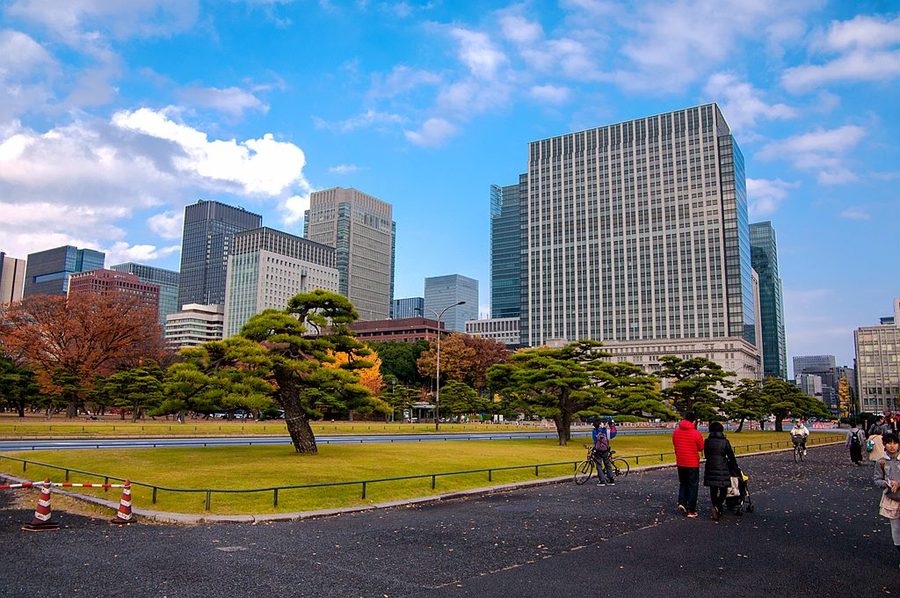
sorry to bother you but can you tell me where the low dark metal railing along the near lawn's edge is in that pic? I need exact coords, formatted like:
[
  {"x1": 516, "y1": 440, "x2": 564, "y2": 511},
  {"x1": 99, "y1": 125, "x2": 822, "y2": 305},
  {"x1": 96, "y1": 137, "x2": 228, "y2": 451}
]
[{"x1": 0, "y1": 434, "x2": 845, "y2": 511}]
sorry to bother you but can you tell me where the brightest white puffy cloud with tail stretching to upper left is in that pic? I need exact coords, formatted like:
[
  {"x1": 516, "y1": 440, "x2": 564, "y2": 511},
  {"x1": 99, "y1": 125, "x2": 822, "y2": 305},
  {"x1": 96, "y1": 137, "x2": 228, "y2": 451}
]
[{"x1": 112, "y1": 108, "x2": 306, "y2": 196}]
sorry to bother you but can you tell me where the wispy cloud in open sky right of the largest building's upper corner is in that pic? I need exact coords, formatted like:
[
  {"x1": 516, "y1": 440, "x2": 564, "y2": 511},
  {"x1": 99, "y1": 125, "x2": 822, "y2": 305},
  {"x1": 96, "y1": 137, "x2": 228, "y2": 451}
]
[{"x1": 756, "y1": 125, "x2": 866, "y2": 185}]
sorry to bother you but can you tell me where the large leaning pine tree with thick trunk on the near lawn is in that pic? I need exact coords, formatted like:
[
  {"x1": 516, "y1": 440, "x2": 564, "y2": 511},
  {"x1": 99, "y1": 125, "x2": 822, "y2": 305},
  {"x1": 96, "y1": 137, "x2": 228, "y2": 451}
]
[{"x1": 167, "y1": 289, "x2": 391, "y2": 453}]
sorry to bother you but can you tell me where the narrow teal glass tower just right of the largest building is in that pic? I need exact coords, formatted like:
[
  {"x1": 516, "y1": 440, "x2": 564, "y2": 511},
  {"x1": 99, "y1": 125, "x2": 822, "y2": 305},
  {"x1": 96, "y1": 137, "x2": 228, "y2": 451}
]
[{"x1": 750, "y1": 222, "x2": 784, "y2": 380}]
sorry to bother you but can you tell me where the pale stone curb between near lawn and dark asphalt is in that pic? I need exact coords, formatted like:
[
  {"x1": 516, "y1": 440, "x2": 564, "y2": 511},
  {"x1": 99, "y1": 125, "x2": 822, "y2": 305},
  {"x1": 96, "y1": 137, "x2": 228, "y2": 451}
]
[{"x1": 3, "y1": 441, "x2": 843, "y2": 525}]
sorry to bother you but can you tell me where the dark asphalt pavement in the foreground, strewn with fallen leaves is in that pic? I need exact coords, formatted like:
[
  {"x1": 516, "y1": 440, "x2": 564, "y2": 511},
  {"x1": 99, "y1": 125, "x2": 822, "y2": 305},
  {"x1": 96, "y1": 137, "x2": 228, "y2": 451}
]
[{"x1": 0, "y1": 446, "x2": 900, "y2": 598}]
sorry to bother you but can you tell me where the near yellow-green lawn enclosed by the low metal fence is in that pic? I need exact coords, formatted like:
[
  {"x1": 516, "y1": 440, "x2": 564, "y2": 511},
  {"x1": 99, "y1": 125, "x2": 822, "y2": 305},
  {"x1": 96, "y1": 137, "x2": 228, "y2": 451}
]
[{"x1": 0, "y1": 432, "x2": 839, "y2": 514}]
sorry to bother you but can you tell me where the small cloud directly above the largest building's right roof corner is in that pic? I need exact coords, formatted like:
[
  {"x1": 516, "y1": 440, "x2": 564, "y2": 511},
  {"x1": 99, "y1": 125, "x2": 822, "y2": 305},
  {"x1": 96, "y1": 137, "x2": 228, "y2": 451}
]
[{"x1": 704, "y1": 72, "x2": 797, "y2": 132}]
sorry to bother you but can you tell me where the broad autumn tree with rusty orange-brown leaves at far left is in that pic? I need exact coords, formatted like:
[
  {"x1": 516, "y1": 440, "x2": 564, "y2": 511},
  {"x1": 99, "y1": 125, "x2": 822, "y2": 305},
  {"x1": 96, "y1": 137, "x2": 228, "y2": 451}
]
[{"x1": 0, "y1": 293, "x2": 170, "y2": 417}]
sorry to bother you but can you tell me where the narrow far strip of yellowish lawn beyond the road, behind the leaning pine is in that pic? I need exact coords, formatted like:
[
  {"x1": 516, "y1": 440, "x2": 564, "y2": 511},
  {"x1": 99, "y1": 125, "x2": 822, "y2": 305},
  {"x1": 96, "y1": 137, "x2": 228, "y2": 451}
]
[{"x1": 0, "y1": 415, "x2": 537, "y2": 440}]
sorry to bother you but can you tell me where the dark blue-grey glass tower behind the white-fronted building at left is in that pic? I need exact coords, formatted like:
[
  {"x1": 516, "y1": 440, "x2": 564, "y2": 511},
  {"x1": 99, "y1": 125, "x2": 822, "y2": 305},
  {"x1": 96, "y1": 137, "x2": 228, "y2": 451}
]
[{"x1": 178, "y1": 199, "x2": 262, "y2": 309}]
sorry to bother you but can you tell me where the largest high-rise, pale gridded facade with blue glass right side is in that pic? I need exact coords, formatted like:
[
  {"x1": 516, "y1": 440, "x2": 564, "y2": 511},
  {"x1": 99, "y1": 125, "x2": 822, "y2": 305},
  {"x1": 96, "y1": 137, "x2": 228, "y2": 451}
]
[{"x1": 520, "y1": 104, "x2": 759, "y2": 377}]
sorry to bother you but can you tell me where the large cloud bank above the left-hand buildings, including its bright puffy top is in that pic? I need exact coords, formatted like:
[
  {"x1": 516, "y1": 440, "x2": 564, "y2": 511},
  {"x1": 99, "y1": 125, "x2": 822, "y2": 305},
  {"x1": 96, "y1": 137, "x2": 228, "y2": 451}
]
[{"x1": 0, "y1": 109, "x2": 309, "y2": 259}]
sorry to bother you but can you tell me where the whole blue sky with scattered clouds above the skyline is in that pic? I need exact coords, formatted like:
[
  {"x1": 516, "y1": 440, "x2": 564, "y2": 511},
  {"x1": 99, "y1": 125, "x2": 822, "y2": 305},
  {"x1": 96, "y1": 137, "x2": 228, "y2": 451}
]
[{"x1": 0, "y1": 0, "x2": 900, "y2": 364}]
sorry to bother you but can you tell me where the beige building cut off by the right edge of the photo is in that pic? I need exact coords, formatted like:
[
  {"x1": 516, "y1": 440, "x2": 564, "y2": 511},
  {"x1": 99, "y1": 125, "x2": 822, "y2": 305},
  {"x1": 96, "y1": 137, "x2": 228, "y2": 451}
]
[{"x1": 853, "y1": 298, "x2": 900, "y2": 413}]
